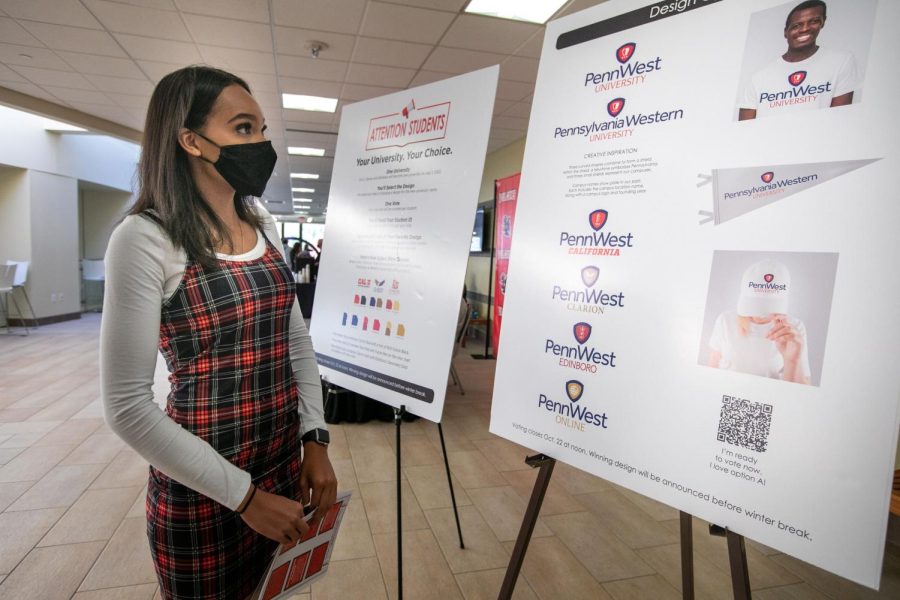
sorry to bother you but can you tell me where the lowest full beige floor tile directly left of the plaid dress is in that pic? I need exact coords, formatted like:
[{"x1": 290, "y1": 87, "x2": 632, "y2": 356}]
[{"x1": 78, "y1": 518, "x2": 156, "y2": 591}]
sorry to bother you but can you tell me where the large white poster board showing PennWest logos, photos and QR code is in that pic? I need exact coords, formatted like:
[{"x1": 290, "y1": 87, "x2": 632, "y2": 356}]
[{"x1": 491, "y1": 0, "x2": 900, "y2": 586}]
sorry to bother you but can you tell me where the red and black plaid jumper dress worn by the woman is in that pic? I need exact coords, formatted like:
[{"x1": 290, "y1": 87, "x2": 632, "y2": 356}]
[{"x1": 146, "y1": 225, "x2": 300, "y2": 600}]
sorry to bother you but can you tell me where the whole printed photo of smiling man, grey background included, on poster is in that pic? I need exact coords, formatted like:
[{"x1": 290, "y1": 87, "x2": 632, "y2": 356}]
[{"x1": 737, "y1": 0, "x2": 875, "y2": 121}]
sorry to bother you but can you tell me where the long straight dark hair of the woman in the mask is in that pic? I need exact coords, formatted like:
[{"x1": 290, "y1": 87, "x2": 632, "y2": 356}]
[{"x1": 129, "y1": 66, "x2": 261, "y2": 267}]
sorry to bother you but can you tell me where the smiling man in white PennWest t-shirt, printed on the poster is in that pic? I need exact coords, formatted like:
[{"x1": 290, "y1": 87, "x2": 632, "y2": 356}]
[{"x1": 738, "y1": 0, "x2": 859, "y2": 121}]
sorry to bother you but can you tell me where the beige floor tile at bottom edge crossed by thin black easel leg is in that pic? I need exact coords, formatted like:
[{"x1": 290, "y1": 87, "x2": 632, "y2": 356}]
[{"x1": 372, "y1": 529, "x2": 462, "y2": 600}]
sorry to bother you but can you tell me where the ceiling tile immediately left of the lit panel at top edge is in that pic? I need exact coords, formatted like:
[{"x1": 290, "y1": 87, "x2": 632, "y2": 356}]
[{"x1": 361, "y1": 1, "x2": 455, "y2": 44}]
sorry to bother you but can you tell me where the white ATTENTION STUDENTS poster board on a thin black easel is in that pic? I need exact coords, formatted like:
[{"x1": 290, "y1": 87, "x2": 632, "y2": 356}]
[{"x1": 310, "y1": 67, "x2": 499, "y2": 421}]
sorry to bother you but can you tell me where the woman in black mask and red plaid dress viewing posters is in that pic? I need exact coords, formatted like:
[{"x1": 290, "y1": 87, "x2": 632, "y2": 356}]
[{"x1": 100, "y1": 67, "x2": 337, "y2": 600}]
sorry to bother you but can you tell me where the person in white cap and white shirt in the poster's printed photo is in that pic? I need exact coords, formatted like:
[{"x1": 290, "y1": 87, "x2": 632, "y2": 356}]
[{"x1": 708, "y1": 260, "x2": 810, "y2": 385}]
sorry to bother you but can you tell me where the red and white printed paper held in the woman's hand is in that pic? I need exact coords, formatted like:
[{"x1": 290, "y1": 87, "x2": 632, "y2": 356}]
[{"x1": 254, "y1": 491, "x2": 351, "y2": 600}]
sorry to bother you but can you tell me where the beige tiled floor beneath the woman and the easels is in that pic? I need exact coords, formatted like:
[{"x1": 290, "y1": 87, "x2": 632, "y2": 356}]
[{"x1": 0, "y1": 314, "x2": 900, "y2": 600}]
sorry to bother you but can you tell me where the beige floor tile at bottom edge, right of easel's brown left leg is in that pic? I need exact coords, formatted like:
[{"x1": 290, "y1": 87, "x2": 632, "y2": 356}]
[{"x1": 504, "y1": 537, "x2": 610, "y2": 600}]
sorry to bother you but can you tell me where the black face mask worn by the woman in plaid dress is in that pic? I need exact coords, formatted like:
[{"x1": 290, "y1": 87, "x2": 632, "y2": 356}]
[{"x1": 191, "y1": 130, "x2": 278, "y2": 198}]
